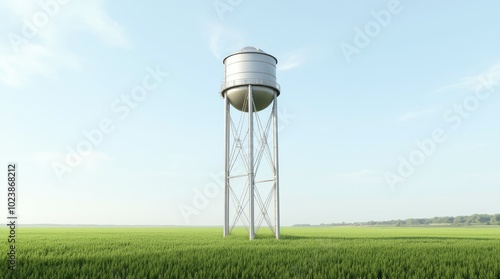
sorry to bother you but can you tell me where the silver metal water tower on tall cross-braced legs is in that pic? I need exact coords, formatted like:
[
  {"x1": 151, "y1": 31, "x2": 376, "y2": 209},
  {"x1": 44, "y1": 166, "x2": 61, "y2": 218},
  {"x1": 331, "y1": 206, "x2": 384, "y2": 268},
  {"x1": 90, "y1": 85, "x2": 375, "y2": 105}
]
[{"x1": 220, "y1": 47, "x2": 280, "y2": 239}]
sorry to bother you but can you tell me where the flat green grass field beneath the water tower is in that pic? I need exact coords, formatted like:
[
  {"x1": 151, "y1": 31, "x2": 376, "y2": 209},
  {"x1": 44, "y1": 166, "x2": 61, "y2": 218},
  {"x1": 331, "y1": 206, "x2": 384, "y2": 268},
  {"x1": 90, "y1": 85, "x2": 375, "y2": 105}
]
[{"x1": 0, "y1": 227, "x2": 500, "y2": 278}]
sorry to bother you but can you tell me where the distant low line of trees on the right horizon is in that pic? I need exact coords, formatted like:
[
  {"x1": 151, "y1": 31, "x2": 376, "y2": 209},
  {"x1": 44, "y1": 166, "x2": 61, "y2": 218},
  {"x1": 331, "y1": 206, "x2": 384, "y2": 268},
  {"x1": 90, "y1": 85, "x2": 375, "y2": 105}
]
[{"x1": 294, "y1": 214, "x2": 500, "y2": 227}]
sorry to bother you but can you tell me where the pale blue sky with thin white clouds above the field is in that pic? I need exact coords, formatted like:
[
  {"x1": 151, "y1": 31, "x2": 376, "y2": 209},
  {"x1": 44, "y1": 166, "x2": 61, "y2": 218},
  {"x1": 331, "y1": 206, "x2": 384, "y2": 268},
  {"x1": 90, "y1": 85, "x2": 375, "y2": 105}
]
[{"x1": 0, "y1": 0, "x2": 500, "y2": 228}]
